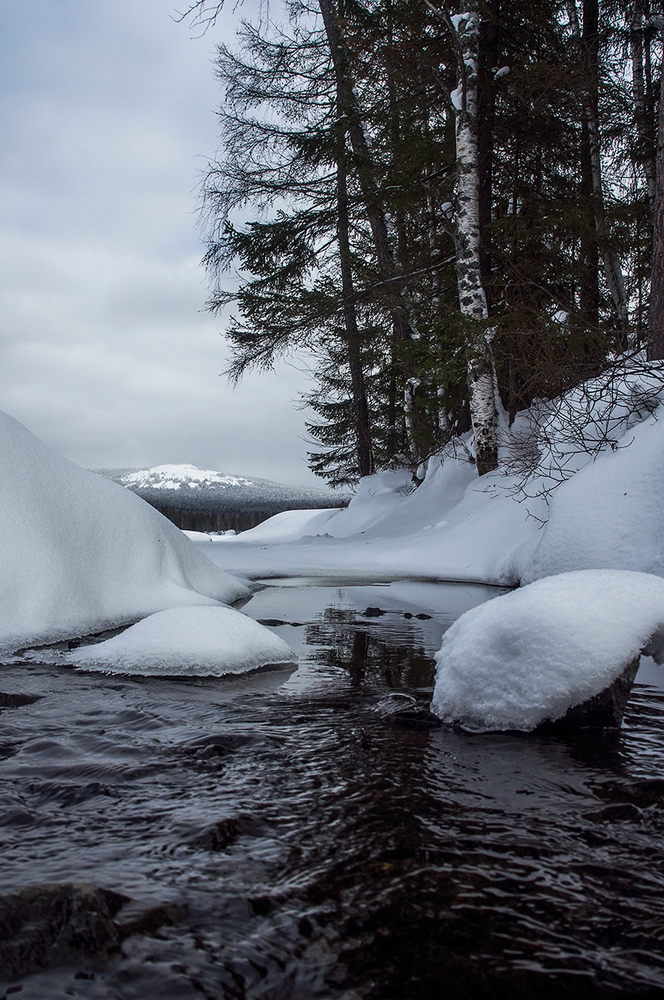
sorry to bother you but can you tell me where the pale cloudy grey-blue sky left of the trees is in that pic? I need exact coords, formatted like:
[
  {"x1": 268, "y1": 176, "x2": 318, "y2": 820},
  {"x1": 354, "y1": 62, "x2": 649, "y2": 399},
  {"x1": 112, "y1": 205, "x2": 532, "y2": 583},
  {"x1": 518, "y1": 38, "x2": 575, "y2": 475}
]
[{"x1": 0, "y1": 0, "x2": 323, "y2": 486}]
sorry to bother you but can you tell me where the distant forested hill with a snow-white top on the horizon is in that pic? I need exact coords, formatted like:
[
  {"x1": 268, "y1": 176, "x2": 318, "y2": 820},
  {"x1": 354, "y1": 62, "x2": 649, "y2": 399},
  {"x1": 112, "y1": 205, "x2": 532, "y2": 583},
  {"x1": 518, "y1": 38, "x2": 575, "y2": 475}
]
[{"x1": 93, "y1": 465, "x2": 350, "y2": 531}]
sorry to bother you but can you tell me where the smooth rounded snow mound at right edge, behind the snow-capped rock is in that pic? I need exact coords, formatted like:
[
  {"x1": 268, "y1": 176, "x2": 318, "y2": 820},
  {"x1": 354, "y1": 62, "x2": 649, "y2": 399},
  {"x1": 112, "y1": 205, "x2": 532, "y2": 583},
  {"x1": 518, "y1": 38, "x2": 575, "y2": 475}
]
[{"x1": 522, "y1": 413, "x2": 664, "y2": 583}]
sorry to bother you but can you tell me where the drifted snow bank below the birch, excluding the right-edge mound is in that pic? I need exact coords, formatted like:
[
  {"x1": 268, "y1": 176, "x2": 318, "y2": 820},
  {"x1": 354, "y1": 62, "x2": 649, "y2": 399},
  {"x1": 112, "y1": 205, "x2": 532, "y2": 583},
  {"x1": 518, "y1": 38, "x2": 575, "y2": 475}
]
[{"x1": 205, "y1": 456, "x2": 546, "y2": 585}]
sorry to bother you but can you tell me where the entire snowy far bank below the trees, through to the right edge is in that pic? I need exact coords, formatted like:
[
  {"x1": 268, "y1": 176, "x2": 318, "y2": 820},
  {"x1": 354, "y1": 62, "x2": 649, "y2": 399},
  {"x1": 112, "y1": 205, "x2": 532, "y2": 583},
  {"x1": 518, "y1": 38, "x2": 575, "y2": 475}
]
[{"x1": 191, "y1": 382, "x2": 664, "y2": 585}]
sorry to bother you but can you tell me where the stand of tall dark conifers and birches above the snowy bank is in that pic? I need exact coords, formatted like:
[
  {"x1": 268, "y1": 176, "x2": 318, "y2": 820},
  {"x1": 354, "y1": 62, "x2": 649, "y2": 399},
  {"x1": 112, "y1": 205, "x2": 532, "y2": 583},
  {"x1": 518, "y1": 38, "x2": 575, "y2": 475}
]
[{"x1": 187, "y1": 0, "x2": 664, "y2": 485}]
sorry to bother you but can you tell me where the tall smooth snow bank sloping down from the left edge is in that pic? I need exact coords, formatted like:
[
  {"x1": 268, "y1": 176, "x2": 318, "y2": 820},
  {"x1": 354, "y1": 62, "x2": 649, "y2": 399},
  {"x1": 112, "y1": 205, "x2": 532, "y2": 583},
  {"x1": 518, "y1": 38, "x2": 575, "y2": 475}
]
[{"x1": 0, "y1": 412, "x2": 249, "y2": 651}]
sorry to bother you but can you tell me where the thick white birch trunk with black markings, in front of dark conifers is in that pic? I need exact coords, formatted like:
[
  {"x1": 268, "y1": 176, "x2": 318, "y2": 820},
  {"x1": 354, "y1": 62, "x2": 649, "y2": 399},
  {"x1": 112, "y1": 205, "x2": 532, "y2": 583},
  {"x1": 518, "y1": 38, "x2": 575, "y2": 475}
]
[{"x1": 452, "y1": 0, "x2": 498, "y2": 476}]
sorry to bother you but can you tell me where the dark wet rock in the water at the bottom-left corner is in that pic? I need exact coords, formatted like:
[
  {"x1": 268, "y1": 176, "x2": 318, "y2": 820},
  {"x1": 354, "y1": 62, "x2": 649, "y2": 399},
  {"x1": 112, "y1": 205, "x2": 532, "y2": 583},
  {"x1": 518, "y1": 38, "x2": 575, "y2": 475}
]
[{"x1": 0, "y1": 882, "x2": 129, "y2": 979}]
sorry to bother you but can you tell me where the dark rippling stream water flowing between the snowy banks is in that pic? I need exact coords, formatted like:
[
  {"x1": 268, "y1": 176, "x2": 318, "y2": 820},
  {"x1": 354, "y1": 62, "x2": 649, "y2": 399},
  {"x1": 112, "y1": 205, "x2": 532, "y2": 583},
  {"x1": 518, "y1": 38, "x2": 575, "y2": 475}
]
[{"x1": 0, "y1": 584, "x2": 664, "y2": 1000}]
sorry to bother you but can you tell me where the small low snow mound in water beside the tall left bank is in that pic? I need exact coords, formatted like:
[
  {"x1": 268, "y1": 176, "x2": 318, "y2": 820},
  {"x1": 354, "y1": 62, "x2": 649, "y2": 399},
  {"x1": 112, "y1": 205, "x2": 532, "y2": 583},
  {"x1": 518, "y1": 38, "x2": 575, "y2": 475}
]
[{"x1": 66, "y1": 607, "x2": 296, "y2": 677}]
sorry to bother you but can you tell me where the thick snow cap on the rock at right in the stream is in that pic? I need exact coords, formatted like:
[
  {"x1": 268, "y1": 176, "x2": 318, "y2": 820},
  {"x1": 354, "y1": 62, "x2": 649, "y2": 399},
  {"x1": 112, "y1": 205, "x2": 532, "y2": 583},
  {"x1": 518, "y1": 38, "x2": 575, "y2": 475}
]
[{"x1": 431, "y1": 570, "x2": 664, "y2": 731}]
